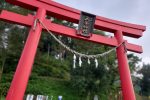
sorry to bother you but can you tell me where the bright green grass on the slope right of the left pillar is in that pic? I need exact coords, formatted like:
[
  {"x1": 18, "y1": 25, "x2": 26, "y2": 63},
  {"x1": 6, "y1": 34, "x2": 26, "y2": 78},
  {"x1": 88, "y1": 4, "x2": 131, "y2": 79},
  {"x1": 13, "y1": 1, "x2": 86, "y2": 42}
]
[{"x1": 26, "y1": 77, "x2": 81, "y2": 100}]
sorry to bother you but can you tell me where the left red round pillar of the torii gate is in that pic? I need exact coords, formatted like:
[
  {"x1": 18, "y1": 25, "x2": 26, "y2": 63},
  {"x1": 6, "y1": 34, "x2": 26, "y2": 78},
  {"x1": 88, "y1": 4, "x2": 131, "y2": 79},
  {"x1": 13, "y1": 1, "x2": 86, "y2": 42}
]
[{"x1": 6, "y1": 8, "x2": 46, "y2": 100}]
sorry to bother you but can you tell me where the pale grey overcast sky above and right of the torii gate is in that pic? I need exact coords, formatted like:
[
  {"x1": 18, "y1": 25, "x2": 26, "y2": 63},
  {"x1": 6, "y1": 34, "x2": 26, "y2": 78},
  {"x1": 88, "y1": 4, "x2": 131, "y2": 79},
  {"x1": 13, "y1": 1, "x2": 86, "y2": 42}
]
[{"x1": 54, "y1": 0, "x2": 150, "y2": 63}]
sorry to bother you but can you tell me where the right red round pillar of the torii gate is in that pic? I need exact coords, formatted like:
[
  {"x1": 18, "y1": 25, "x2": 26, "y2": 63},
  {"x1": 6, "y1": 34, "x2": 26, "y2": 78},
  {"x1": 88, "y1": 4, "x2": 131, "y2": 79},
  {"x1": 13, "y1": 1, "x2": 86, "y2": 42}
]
[{"x1": 115, "y1": 31, "x2": 136, "y2": 100}]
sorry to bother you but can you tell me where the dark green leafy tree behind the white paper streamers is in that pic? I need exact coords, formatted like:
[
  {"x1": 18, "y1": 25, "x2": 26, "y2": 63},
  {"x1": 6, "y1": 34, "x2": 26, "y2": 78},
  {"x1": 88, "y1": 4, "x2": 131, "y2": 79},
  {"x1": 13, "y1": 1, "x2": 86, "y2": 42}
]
[{"x1": 70, "y1": 30, "x2": 118, "y2": 100}]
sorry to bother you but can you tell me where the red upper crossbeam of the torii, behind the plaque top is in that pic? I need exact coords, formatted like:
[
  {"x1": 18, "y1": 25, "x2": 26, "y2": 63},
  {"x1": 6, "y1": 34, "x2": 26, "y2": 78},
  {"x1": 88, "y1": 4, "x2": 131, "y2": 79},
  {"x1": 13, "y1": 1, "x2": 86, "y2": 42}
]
[{"x1": 6, "y1": 0, "x2": 145, "y2": 38}]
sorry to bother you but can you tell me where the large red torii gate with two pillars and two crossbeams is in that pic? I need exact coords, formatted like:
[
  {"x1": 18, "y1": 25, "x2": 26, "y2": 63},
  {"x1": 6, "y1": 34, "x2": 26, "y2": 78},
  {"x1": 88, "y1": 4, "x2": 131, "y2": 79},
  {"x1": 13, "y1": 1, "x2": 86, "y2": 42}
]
[{"x1": 0, "y1": 0, "x2": 146, "y2": 100}]
